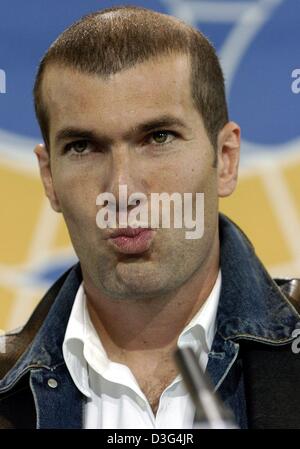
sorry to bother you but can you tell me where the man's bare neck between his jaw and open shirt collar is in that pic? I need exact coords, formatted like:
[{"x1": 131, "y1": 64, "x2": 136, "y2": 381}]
[{"x1": 84, "y1": 238, "x2": 219, "y2": 354}]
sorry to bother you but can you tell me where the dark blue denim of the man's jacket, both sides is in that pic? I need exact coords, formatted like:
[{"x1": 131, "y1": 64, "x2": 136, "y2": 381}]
[{"x1": 0, "y1": 215, "x2": 300, "y2": 428}]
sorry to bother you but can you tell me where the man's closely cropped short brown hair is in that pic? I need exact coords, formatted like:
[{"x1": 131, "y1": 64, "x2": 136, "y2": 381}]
[{"x1": 34, "y1": 6, "x2": 228, "y2": 158}]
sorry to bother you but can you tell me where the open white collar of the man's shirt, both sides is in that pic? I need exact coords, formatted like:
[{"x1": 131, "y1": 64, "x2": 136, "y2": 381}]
[{"x1": 62, "y1": 270, "x2": 221, "y2": 397}]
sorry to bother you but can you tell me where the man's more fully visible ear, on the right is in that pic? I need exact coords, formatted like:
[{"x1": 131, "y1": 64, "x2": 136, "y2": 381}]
[{"x1": 218, "y1": 122, "x2": 241, "y2": 197}]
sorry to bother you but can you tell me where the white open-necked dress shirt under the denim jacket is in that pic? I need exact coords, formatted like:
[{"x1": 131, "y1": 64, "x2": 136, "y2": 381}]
[{"x1": 63, "y1": 271, "x2": 221, "y2": 429}]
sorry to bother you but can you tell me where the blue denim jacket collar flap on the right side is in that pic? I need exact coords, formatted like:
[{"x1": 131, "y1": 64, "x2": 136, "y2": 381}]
[{"x1": 217, "y1": 215, "x2": 300, "y2": 344}]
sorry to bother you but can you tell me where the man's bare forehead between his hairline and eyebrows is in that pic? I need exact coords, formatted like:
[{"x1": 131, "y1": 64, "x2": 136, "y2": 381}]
[{"x1": 42, "y1": 55, "x2": 197, "y2": 134}]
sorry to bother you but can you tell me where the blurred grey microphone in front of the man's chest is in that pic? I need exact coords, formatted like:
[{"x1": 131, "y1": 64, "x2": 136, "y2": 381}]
[{"x1": 174, "y1": 347, "x2": 238, "y2": 429}]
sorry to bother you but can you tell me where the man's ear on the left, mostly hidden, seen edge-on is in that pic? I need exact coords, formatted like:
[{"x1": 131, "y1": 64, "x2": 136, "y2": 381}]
[{"x1": 34, "y1": 144, "x2": 61, "y2": 212}]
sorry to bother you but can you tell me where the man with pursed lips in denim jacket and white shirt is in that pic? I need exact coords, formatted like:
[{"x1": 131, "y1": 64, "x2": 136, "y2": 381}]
[{"x1": 0, "y1": 7, "x2": 300, "y2": 428}]
